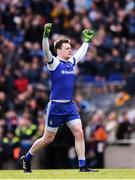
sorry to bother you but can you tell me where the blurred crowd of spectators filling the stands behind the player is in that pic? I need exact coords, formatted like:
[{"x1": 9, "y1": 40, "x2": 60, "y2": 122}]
[{"x1": 0, "y1": 0, "x2": 135, "y2": 168}]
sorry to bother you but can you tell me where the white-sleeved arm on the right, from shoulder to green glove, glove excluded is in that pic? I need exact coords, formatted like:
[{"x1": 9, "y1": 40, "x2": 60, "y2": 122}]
[{"x1": 74, "y1": 42, "x2": 89, "y2": 62}]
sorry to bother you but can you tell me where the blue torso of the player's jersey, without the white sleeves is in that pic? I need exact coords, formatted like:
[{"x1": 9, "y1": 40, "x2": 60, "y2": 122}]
[{"x1": 50, "y1": 59, "x2": 75, "y2": 100}]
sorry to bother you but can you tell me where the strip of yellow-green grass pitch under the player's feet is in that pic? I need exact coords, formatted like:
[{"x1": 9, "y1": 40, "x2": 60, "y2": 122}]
[{"x1": 0, "y1": 169, "x2": 135, "y2": 180}]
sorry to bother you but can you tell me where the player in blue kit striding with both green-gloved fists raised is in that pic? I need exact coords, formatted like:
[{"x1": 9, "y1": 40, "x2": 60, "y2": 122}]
[{"x1": 20, "y1": 23, "x2": 96, "y2": 172}]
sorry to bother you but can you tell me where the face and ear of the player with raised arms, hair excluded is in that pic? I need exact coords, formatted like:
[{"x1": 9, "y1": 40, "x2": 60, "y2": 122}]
[{"x1": 57, "y1": 43, "x2": 72, "y2": 60}]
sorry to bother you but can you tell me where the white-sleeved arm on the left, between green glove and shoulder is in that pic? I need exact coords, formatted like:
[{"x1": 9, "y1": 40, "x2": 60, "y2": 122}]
[{"x1": 42, "y1": 37, "x2": 52, "y2": 62}]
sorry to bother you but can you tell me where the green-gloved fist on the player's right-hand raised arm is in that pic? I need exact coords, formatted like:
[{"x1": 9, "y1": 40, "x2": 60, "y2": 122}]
[{"x1": 82, "y1": 29, "x2": 95, "y2": 43}]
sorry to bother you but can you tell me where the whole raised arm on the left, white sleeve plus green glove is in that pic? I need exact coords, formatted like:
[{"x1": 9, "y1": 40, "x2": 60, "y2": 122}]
[{"x1": 42, "y1": 23, "x2": 53, "y2": 63}]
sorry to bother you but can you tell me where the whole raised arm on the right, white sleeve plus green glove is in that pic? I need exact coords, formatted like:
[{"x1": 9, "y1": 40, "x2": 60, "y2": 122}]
[{"x1": 73, "y1": 29, "x2": 95, "y2": 63}]
